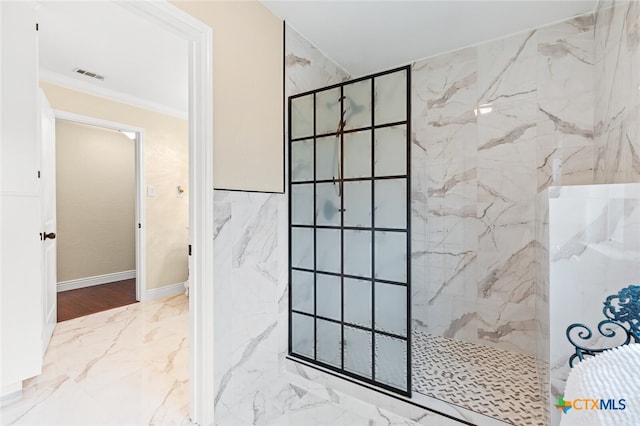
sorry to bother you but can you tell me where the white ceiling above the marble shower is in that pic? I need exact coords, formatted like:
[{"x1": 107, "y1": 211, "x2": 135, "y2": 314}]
[{"x1": 261, "y1": 0, "x2": 596, "y2": 77}]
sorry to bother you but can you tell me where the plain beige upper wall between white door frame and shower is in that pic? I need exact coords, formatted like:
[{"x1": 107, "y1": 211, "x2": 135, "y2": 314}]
[{"x1": 172, "y1": 1, "x2": 284, "y2": 192}]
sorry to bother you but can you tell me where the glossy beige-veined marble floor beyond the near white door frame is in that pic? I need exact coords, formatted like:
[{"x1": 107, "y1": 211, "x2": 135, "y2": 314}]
[{"x1": 0, "y1": 294, "x2": 189, "y2": 425}]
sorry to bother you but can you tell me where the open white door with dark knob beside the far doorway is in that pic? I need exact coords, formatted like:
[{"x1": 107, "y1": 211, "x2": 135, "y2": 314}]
[{"x1": 40, "y1": 90, "x2": 58, "y2": 353}]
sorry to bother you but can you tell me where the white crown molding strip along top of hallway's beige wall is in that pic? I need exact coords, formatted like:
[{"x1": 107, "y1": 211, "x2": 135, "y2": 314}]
[{"x1": 40, "y1": 69, "x2": 189, "y2": 120}]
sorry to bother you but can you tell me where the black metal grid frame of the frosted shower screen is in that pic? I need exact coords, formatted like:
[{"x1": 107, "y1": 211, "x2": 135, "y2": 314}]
[{"x1": 288, "y1": 66, "x2": 411, "y2": 397}]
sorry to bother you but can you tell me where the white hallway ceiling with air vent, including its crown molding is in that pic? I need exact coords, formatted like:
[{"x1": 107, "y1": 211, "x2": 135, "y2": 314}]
[{"x1": 38, "y1": 1, "x2": 189, "y2": 117}]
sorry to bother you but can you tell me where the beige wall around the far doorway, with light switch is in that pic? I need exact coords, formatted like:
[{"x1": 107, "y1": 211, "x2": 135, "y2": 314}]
[{"x1": 40, "y1": 82, "x2": 189, "y2": 289}]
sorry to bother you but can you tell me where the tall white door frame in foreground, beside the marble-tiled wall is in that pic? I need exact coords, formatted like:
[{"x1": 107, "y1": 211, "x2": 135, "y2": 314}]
[{"x1": 118, "y1": 1, "x2": 215, "y2": 425}]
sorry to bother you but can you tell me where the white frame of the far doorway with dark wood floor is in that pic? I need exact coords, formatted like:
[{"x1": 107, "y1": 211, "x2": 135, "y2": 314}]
[{"x1": 53, "y1": 109, "x2": 147, "y2": 302}]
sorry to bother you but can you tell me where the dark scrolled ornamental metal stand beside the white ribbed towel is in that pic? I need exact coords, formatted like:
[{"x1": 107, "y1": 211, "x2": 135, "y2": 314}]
[{"x1": 566, "y1": 285, "x2": 640, "y2": 367}]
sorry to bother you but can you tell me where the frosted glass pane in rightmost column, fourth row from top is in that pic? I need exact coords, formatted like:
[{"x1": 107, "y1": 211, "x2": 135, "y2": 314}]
[{"x1": 375, "y1": 232, "x2": 407, "y2": 283}]
